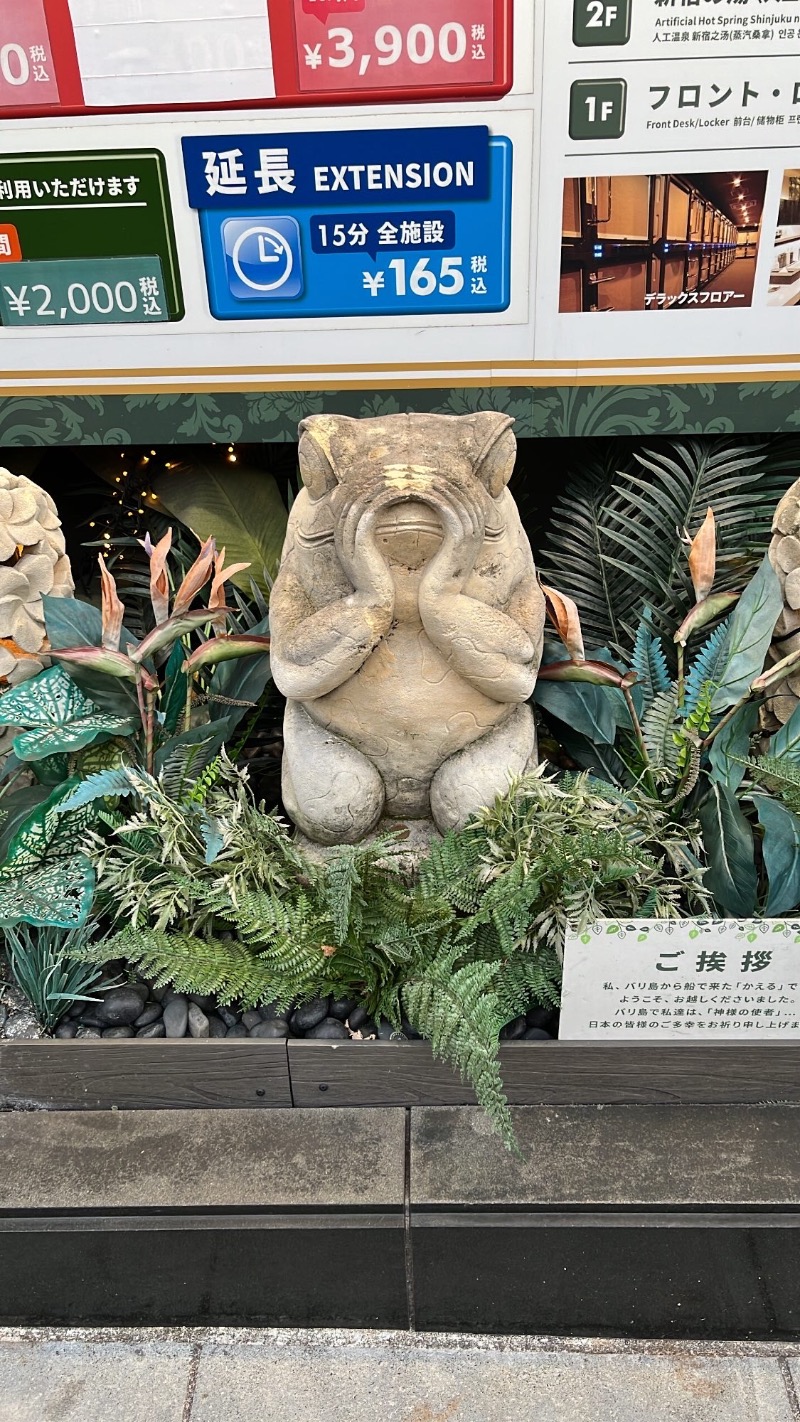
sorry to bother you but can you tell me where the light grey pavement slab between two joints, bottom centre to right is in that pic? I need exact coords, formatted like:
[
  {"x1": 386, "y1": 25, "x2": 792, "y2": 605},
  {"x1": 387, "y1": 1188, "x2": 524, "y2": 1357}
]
[{"x1": 192, "y1": 1338, "x2": 793, "y2": 1422}]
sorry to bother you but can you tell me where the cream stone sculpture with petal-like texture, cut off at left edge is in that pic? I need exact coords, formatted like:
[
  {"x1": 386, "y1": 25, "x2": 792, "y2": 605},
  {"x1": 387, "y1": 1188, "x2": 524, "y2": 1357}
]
[{"x1": 0, "y1": 469, "x2": 75, "y2": 688}]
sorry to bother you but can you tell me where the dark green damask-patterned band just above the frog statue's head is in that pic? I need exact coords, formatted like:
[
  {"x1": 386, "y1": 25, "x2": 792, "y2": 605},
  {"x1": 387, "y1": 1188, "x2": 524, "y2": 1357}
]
[{"x1": 0, "y1": 381, "x2": 800, "y2": 445}]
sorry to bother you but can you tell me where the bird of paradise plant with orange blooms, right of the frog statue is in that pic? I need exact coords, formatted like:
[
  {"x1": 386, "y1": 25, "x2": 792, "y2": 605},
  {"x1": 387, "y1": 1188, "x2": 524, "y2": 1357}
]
[{"x1": 536, "y1": 508, "x2": 800, "y2": 917}]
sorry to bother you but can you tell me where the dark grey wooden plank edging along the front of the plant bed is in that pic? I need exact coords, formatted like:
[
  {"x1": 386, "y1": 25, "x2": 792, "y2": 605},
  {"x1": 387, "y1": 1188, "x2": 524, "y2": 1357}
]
[{"x1": 0, "y1": 1039, "x2": 800, "y2": 1111}]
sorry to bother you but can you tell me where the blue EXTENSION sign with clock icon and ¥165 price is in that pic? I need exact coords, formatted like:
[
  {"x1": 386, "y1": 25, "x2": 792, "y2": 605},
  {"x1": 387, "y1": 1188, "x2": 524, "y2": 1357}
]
[{"x1": 183, "y1": 125, "x2": 512, "y2": 320}]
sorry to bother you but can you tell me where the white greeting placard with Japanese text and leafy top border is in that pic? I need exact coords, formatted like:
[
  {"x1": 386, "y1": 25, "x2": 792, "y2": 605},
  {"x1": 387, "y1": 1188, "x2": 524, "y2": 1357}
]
[{"x1": 558, "y1": 919, "x2": 800, "y2": 1042}]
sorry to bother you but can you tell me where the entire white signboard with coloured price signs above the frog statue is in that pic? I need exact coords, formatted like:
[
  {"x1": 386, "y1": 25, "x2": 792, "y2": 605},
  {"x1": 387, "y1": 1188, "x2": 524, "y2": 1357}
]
[{"x1": 0, "y1": 0, "x2": 800, "y2": 392}]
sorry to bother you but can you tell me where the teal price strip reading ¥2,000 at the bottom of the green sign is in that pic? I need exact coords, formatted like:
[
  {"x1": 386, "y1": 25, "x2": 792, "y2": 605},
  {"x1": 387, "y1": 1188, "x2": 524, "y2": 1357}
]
[{"x1": 0, "y1": 257, "x2": 169, "y2": 326}]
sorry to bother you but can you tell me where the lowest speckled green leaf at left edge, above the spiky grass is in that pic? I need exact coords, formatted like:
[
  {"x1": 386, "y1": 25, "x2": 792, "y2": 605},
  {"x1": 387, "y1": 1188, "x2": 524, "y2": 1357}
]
[{"x1": 0, "y1": 855, "x2": 95, "y2": 929}]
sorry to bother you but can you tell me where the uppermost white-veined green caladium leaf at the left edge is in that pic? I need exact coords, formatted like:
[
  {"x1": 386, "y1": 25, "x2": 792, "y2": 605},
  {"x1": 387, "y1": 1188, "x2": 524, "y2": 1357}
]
[{"x1": 0, "y1": 668, "x2": 136, "y2": 761}]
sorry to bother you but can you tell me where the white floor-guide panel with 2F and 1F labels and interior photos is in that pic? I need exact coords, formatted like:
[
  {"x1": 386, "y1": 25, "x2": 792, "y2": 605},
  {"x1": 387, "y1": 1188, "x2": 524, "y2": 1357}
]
[{"x1": 534, "y1": 0, "x2": 800, "y2": 378}]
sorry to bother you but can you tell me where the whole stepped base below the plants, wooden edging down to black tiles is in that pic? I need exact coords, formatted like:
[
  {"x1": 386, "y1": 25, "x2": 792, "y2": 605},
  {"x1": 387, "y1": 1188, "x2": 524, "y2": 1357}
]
[{"x1": 0, "y1": 1039, "x2": 800, "y2": 1340}]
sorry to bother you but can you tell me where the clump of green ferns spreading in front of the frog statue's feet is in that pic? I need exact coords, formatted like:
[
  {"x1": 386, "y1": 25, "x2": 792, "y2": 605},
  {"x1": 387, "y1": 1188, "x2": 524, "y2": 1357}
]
[{"x1": 67, "y1": 755, "x2": 702, "y2": 1143}]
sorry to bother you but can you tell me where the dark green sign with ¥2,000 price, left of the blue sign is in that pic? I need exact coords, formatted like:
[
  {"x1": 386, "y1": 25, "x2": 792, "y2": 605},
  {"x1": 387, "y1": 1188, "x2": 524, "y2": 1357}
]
[{"x1": 0, "y1": 149, "x2": 183, "y2": 326}]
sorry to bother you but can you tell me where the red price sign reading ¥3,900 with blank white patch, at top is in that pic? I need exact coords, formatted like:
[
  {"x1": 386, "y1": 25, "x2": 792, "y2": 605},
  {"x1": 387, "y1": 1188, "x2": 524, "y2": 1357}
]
[{"x1": 0, "y1": 0, "x2": 513, "y2": 117}]
